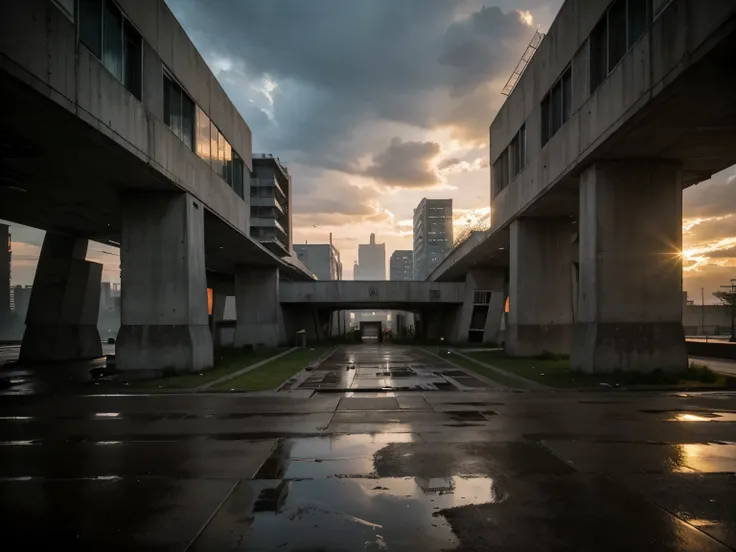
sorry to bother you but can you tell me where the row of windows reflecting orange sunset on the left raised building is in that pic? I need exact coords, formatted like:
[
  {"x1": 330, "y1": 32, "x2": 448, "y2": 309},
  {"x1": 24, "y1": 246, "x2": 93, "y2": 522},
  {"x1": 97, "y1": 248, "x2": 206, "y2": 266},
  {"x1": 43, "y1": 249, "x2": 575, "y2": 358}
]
[{"x1": 164, "y1": 75, "x2": 245, "y2": 197}]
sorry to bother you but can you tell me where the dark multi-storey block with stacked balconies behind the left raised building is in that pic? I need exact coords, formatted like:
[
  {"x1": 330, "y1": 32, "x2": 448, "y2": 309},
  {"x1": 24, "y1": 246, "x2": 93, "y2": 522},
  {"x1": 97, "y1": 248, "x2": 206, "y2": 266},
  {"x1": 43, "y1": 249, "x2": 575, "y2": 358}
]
[{"x1": 250, "y1": 153, "x2": 292, "y2": 257}]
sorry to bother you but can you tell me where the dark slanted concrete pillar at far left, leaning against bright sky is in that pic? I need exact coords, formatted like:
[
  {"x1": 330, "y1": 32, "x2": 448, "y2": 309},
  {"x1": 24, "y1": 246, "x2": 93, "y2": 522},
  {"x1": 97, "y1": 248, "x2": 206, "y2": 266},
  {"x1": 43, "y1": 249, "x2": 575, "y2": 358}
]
[{"x1": 20, "y1": 232, "x2": 102, "y2": 362}]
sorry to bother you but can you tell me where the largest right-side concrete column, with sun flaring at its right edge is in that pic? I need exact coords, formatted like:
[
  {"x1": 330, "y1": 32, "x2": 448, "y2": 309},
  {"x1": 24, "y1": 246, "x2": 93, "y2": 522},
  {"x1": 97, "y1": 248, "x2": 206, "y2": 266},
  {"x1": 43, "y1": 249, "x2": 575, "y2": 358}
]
[{"x1": 571, "y1": 162, "x2": 687, "y2": 372}]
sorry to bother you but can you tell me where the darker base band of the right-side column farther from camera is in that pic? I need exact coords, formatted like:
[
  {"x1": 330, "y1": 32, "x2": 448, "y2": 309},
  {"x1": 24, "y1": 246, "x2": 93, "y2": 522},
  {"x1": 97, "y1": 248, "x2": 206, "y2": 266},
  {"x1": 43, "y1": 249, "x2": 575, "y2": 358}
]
[{"x1": 504, "y1": 324, "x2": 573, "y2": 357}]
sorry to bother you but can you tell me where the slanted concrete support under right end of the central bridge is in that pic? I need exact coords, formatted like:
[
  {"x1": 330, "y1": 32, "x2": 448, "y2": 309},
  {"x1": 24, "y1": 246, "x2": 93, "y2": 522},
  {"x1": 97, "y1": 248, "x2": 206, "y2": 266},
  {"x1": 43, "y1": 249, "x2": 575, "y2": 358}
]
[{"x1": 454, "y1": 269, "x2": 506, "y2": 343}]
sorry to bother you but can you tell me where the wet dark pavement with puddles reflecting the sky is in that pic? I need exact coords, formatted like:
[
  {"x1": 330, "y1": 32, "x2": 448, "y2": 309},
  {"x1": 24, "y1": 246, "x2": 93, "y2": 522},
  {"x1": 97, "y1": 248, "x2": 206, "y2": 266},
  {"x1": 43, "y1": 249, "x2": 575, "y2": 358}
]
[{"x1": 0, "y1": 346, "x2": 736, "y2": 551}]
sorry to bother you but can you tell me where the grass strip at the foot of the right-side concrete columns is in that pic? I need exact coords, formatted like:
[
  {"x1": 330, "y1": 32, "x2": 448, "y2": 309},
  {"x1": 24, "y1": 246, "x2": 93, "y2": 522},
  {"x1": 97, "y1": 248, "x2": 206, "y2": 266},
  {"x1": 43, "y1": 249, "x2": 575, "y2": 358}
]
[{"x1": 462, "y1": 351, "x2": 736, "y2": 388}]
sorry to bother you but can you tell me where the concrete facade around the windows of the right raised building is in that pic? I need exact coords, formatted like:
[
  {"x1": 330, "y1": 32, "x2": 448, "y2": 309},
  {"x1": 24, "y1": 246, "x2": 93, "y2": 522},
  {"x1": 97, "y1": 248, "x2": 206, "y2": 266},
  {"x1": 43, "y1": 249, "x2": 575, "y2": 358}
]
[{"x1": 490, "y1": 0, "x2": 736, "y2": 228}]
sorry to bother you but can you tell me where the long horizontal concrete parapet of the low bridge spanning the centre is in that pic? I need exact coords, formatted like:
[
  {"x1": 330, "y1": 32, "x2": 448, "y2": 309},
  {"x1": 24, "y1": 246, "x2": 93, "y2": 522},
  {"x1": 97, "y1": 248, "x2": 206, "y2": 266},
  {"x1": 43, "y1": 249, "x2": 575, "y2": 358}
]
[{"x1": 280, "y1": 280, "x2": 465, "y2": 309}]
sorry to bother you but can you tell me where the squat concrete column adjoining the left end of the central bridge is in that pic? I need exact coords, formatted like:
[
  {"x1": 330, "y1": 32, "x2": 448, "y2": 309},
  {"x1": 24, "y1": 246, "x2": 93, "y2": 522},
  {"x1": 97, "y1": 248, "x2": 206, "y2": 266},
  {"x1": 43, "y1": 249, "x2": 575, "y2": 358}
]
[{"x1": 235, "y1": 268, "x2": 284, "y2": 347}]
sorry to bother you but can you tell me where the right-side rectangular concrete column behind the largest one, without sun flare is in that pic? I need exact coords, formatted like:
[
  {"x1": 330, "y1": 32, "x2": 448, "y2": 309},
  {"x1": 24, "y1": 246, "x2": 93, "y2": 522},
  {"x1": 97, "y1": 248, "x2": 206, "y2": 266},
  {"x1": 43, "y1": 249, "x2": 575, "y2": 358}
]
[{"x1": 505, "y1": 217, "x2": 573, "y2": 357}]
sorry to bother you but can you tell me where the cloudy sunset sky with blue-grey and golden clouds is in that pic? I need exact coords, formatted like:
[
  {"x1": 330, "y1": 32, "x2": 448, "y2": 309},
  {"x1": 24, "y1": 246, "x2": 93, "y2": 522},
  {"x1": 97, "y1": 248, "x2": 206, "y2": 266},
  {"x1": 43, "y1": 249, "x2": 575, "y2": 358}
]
[{"x1": 5, "y1": 0, "x2": 736, "y2": 297}]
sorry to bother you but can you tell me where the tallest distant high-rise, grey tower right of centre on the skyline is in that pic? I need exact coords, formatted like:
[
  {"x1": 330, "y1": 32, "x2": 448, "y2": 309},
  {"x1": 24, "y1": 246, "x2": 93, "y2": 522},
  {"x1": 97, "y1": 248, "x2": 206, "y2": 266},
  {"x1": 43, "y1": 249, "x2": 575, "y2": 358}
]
[{"x1": 414, "y1": 197, "x2": 452, "y2": 280}]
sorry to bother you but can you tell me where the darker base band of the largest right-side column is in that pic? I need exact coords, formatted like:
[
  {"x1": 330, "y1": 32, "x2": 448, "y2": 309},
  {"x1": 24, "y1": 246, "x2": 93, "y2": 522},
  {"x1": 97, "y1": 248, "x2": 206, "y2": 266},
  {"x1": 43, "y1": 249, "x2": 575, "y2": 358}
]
[{"x1": 570, "y1": 322, "x2": 687, "y2": 373}]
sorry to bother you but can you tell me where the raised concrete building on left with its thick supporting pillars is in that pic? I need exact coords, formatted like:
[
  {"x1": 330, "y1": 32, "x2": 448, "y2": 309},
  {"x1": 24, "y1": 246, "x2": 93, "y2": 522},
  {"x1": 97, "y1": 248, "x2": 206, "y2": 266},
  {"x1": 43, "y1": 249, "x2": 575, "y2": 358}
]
[{"x1": 0, "y1": 0, "x2": 311, "y2": 371}]
